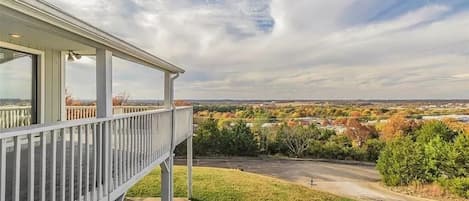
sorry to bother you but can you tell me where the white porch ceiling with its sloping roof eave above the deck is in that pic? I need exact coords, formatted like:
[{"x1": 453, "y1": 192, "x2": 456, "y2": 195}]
[{"x1": 0, "y1": 0, "x2": 184, "y2": 73}]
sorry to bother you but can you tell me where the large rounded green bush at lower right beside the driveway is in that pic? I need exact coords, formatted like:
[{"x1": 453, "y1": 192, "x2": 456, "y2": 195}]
[{"x1": 377, "y1": 121, "x2": 469, "y2": 198}]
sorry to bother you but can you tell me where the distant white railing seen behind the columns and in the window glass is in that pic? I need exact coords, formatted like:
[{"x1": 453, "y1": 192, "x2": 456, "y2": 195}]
[{"x1": 0, "y1": 106, "x2": 161, "y2": 129}]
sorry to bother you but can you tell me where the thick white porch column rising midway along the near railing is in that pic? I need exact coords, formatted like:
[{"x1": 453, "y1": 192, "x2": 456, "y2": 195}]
[{"x1": 96, "y1": 49, "x2": 112, "y2": 196}]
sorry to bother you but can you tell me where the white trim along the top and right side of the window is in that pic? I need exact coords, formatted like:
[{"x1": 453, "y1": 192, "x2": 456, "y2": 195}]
[{"x1": 0, "y1": 41, "x2": 45, "y2": 124}]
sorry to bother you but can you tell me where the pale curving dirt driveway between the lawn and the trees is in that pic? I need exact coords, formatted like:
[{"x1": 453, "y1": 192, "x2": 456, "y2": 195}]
[{"x1": 177, "y1": 159, "x2": 427, "y2": 201}]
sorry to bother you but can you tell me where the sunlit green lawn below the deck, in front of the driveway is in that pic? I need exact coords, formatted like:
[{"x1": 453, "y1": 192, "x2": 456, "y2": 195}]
[{"x1": 127, "y1": 166, "x2": 350, "y2": 201}]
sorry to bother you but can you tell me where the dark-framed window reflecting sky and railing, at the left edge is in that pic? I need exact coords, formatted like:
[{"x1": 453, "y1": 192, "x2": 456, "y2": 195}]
[{"x1": 0, "y1": 47, "x2": 37, "y2": 129}]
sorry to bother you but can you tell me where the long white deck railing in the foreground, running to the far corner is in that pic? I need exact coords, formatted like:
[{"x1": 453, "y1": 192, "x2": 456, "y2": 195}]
[{"x1": 0, "y1": 107, "x2": 192, "y2": 201}]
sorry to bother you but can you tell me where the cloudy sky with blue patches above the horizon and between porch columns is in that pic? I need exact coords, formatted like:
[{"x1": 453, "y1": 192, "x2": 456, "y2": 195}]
[{"x1": 38, "y1": 0, "x2": 469, "y2": 99}]
